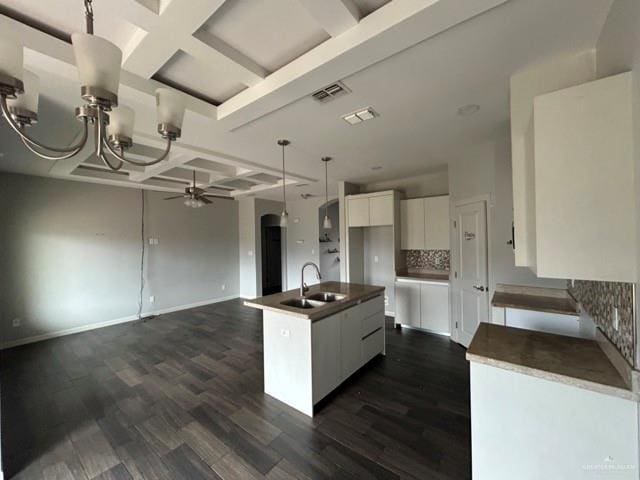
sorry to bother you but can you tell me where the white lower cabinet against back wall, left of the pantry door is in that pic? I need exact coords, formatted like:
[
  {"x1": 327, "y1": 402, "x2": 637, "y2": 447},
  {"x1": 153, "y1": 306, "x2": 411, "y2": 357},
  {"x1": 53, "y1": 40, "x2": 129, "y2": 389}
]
[{"x1": 395, "y1": 280, "x2": 451, "y2": 334}]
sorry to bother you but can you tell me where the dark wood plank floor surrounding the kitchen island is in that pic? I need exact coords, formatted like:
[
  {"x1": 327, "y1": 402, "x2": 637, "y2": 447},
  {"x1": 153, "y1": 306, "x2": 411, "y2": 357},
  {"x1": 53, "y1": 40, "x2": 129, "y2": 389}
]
[{"x1": 0, "y1": 300, "x2": 471, "y2": 479}]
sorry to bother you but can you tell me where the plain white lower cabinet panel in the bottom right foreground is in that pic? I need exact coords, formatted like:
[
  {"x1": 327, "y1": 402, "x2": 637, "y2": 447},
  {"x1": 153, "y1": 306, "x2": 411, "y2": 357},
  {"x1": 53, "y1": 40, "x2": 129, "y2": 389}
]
[{"x1": 470, "y1": 361, "x2": 640, "y2": 480}]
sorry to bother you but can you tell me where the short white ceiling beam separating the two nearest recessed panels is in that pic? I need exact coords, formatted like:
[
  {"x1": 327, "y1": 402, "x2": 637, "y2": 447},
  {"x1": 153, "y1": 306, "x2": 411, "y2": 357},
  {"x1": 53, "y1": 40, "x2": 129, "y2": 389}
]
[{"x1": 182, "y1": 32, "x2": 268, "y2": 87}]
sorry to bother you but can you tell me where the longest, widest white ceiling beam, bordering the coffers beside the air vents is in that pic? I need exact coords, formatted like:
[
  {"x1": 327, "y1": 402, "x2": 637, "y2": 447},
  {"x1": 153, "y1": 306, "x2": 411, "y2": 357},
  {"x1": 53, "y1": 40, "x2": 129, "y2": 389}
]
[{"x1": 218, "y1": 0, "x2": 509, "y2": 130}]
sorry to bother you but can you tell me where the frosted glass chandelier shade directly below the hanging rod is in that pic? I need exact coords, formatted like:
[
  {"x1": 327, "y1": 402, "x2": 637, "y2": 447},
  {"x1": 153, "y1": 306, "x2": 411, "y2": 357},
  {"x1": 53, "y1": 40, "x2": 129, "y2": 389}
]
[{"x1": 71, "y1": 32, "x2": 122, "y2": 95}]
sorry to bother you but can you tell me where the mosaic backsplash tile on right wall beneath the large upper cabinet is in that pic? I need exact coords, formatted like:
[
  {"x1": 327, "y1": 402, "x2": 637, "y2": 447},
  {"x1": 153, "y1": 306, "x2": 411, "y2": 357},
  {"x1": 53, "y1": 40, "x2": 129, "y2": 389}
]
[{"x1": 567, "y1": 280, "x2": 634, "y2": 365}]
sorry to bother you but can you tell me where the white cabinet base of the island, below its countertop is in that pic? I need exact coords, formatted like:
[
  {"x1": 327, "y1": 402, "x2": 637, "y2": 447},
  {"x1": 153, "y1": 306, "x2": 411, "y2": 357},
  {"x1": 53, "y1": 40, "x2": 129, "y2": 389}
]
[{"x1": 256, "y1": 290, "x2": 385, "y2": 416}]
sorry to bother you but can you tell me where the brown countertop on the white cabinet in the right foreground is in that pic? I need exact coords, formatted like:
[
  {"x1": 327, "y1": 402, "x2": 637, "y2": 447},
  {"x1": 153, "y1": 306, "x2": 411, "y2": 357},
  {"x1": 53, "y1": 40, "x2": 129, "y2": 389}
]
[{"x1": 467, "y1": 323, "x2": 638, "y2": 400}]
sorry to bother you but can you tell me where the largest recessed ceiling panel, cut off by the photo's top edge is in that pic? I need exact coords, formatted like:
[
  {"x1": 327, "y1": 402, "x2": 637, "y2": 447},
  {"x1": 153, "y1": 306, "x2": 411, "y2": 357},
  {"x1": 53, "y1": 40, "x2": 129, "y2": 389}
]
[{"x1": 203, "y1": 0, "x2": 329, "y2": 72}]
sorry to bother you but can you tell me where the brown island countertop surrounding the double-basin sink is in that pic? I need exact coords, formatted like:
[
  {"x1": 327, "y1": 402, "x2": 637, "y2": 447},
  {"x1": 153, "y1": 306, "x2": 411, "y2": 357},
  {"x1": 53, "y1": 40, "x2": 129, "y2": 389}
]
[{"x1": 244, "y1": 282, "x2": 384, "y2": 322}]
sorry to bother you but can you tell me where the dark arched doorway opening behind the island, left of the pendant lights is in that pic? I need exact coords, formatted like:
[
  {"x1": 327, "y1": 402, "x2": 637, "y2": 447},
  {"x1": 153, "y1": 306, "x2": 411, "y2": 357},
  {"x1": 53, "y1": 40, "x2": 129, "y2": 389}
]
[{"x1": 260, "y1": 214, "x2": 283, "y2": 295}]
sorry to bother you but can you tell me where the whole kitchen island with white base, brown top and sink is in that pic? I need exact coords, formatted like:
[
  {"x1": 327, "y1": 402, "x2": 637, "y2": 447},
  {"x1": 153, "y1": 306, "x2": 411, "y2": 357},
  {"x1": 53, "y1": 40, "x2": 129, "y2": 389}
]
[{"x1": 245, "y1": 282, "x2": 385, "y2": 416}]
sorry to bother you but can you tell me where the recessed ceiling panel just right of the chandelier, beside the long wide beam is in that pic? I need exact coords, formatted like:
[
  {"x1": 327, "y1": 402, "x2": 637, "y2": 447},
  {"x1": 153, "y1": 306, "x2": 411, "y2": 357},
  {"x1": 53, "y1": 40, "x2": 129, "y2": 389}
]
[{"x1": 154, "y1": 50, "x2": 246, "y2": 105}]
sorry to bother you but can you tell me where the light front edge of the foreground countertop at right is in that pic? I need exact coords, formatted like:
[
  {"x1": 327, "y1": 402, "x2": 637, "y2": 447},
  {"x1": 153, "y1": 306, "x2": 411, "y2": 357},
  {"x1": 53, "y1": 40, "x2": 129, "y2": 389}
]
[{"x1": 465, "y1": 352, "x2": 640, "y2": 402}]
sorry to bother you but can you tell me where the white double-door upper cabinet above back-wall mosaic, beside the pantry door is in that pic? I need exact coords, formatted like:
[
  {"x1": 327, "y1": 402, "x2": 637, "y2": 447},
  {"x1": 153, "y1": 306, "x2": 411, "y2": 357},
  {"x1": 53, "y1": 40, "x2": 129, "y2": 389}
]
[{"x1": 400, "y1": 195, "x2": 449, "y2": 250}]
